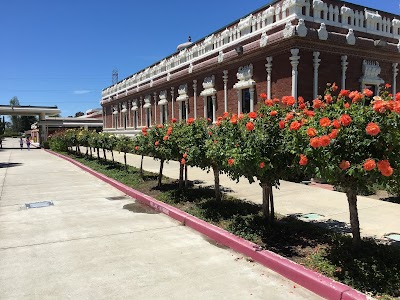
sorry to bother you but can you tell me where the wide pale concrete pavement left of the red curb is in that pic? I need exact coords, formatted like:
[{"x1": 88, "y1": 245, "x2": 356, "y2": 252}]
[{"x1": 0, "y1": 139, "x2": 319, "y2": 300}]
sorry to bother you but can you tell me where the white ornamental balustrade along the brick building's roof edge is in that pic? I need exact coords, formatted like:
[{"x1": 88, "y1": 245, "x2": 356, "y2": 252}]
[{"x1": 102, "y1": 0, "x2": 400, "y2": 98}]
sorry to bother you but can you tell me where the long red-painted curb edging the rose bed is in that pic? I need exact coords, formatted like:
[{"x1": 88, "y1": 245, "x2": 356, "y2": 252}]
[{"x1": 45, "y1": 149, "x2": 368, "y2": 300}]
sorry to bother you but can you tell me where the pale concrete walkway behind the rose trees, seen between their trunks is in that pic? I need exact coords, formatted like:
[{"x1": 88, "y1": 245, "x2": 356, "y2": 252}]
[{"x1": 82, "y1": 145, "x2": 400, "y2": 240}]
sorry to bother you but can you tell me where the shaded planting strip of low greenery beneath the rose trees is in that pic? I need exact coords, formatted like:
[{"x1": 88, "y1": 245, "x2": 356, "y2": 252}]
[{"x1": 68, "y1": 154, "x2": 400, "y2": 299}]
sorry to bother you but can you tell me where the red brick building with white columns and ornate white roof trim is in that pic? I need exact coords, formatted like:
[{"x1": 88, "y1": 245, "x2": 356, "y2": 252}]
[{"x1": 101, "y1": 0, "x2": 400, "y2": 135}]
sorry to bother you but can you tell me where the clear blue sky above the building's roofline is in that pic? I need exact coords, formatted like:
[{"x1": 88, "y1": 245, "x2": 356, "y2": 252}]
[{"x1": 0, "y1": 0, "x2": 400, "y2": 116}]
